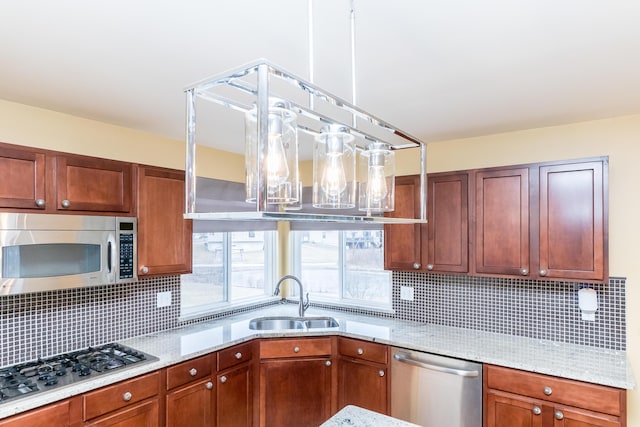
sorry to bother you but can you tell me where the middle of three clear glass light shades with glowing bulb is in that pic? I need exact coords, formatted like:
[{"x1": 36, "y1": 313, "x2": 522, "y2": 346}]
[{"x1": 313, "y1": 125, "x2": 356, "y2": 209}]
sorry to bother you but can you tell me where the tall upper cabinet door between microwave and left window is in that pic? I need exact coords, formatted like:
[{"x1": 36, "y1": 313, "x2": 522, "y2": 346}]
[{"x1": 138, "y1": 166, "x2": 192, "y2": 276}]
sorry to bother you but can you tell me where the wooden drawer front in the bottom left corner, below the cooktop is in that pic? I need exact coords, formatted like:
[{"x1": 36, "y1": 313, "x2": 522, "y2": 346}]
[{"x1": 0, "y1": 398, "x2": 82, "y2": 427}]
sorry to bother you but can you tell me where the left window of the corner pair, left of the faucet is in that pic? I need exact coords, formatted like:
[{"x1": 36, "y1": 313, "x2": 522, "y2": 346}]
[{"x1": 180, "y1": 231, "x2": 276, "y2": 317}]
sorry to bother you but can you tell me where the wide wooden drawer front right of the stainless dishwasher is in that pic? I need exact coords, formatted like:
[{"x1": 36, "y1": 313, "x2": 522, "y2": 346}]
[{"x1": 486, "y1": 365, "x2": 626, "y2": 415}]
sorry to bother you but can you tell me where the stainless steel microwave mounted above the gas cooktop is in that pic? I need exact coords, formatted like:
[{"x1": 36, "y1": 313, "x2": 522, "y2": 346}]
[{"x1": 0, "y1": 213, "x2": 138, "y2": 295}]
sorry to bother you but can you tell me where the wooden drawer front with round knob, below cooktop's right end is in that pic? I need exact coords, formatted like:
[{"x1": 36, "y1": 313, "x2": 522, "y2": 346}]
[{"x1": 84, "y1": 372, "x2": 160, "y2": 420}]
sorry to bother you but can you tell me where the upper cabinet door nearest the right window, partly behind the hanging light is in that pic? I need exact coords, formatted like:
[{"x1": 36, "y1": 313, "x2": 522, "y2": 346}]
[{"x1": 384, "y1": 175, "x2": 422, "y2": 271}]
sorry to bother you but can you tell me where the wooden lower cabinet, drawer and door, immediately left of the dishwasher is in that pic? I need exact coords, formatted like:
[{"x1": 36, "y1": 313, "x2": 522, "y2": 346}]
[{"x1": 338, "y1": 338, "x2": 390, "y2": 415}]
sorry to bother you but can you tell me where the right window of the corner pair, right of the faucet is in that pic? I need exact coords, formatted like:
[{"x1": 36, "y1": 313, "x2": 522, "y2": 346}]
[{"x1": 292, "y1": 230, "x2": 391, "y2": 308}]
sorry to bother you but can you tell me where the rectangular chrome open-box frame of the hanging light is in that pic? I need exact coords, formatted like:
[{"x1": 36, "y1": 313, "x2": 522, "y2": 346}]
[{"x1": 184, "y1": 59, "x2": 427, "y2": 224}]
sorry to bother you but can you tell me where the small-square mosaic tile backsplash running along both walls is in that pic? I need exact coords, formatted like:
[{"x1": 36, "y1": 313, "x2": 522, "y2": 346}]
[{"x1": 0, "y1": 273, "x2": 626, "y2": 366}]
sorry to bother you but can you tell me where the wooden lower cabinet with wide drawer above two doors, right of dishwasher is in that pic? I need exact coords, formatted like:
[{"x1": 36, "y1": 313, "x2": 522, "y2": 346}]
[{"x1": 484, "y1": 365, "x2": 627, "y2": 427}]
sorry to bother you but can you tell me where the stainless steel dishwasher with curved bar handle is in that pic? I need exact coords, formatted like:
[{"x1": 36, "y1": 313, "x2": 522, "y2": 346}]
[{"x1": 391, "y1": 347, "x2": 482, "y2": 427}]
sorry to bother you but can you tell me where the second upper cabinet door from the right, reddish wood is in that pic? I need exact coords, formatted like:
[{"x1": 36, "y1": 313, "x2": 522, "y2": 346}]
[{"x1": 475, "y1": 167, "x2": 530, "y2": 276}]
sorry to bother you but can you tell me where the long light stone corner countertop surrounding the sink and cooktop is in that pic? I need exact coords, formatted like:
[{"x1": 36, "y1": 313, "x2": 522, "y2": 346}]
[{"x1": 0, "y1": 304, "x2": 635, "y2": 418}]
